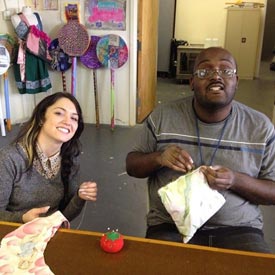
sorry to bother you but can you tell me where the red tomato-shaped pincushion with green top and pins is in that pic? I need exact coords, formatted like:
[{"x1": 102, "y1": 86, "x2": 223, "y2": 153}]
[{"x1": 100, "y1": 231, "x2": 124, "y2": 253}]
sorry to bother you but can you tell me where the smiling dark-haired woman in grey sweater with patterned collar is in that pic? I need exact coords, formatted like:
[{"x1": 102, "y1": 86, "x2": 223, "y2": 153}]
[{"x1": 0, "y1": 92, "x2": 97, "y2": 223}]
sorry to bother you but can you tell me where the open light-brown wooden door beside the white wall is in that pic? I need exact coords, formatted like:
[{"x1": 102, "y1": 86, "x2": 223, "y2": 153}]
[{"x1": 137, "y1": 0, "x2": 159, "y2": 123}]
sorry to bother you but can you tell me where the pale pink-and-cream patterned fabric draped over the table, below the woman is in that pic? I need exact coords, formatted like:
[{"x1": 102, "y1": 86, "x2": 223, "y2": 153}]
[{"x1": 0, "y1": 211, "x2": 69, "y2": 275}]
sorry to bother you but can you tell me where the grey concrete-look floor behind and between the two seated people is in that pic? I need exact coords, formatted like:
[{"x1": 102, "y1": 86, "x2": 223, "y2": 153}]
[{"x1": 0, "y1": 62, "x2": 275, "y2": 252}]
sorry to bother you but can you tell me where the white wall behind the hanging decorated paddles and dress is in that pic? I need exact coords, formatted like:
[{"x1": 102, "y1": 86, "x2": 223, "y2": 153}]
[{"x1": 0, "y1": 0, "x2": 138, "y2": 126}]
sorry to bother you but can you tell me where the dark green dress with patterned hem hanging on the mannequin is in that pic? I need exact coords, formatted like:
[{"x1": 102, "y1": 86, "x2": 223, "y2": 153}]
[{"x1": 14, "y1": 12, "x2": 52, "y2": 94}]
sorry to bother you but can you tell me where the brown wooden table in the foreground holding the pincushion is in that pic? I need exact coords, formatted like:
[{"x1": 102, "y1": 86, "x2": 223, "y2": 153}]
[{"x1": 0, "y1": 222, "x2": 275, "y2": 275}]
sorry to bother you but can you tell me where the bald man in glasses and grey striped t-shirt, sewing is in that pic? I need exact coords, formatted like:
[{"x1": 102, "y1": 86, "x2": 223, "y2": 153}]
[{"x1": 126, "y1": 47, "x2": 275, "y2": 253}]
